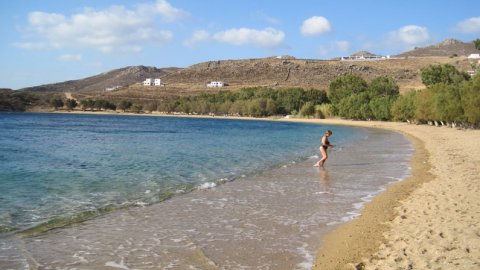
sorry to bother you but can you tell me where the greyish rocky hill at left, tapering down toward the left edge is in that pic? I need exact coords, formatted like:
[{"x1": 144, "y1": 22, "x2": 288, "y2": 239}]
[{"x1": 21, "y1": 66, "x2": 177, "y2": 93}]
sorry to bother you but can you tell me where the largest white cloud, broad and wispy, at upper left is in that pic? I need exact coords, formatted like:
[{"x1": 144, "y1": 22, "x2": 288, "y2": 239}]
[{"x1": 16, "y1": 0, "x2": 187, "y2": 53}]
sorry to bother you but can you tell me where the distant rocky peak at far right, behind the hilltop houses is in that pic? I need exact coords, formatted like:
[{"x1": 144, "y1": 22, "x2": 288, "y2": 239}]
[{"x1": 398, "y1": 39, "x2": 480, "y2": 57}]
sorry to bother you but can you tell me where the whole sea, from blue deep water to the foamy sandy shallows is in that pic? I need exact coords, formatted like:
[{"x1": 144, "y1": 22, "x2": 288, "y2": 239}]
[{"x1": 0, "y1": 113, "x2": 414, "y2": 269}]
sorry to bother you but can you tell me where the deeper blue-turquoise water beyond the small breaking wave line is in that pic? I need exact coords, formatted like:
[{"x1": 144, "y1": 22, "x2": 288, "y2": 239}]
[{"x1": 0, "y1": 113, "x2": 364, "y2": 231}]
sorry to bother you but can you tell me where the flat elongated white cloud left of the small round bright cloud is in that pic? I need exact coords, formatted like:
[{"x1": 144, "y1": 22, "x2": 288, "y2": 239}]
[{"x1": 213, "y1": 28, "x2": 285, "y2": 48}]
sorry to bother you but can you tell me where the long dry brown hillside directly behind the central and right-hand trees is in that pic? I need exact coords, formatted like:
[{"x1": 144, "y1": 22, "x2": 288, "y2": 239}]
[{"x1": 132, "y1": 54, "x2": 469, "y2": 91}]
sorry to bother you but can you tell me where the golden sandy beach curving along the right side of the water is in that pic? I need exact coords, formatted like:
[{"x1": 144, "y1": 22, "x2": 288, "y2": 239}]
[{"x1": 282, "y1": 120, "x2": 480, "y2": 270}]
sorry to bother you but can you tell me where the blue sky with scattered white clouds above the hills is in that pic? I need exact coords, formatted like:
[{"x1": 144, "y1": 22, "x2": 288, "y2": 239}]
[{"x1": 0, "y1": 0, "x2": 480, "y2": 89}]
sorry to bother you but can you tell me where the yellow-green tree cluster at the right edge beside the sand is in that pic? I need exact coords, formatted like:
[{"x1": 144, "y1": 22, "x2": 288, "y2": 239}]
[{"x1": 392, "y1": 64, "x2": 480, "y2": 127}]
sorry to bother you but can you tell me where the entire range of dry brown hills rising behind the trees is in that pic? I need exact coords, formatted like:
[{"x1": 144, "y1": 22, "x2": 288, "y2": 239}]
[{"x1": 16, "y1": 39, "x2": 479, "y2": 99}]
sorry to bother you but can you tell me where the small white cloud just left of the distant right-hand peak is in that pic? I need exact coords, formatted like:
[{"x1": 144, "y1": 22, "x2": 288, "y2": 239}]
[{"x1": 387, "y1": 25, "x2": 430, "y2": 49}]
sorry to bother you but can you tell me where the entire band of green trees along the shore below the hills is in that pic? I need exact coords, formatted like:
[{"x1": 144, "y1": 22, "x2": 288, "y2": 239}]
[{"x1": 0, "y1": 62, "x2": 480, "y2": 127}]
